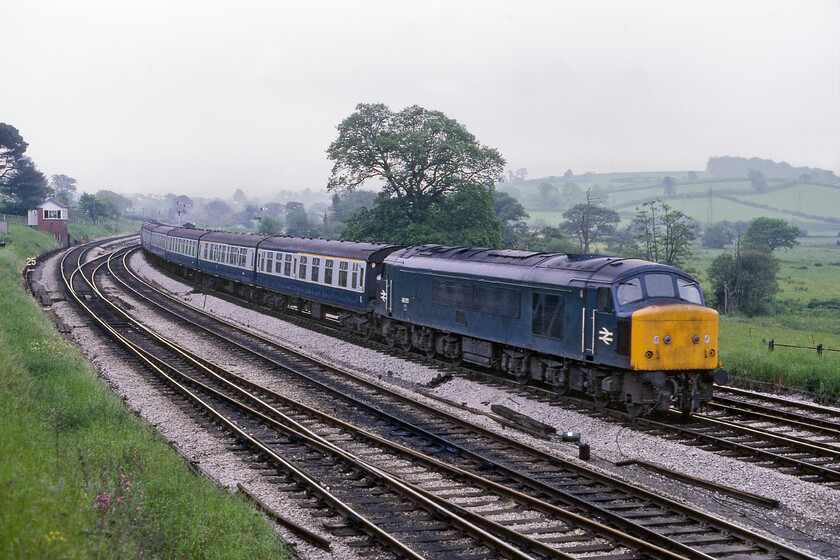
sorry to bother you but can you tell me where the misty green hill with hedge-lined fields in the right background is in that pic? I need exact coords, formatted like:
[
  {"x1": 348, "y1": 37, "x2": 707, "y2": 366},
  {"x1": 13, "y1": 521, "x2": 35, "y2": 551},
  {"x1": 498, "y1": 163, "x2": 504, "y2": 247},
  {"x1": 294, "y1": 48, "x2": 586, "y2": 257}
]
[{"x1": 498, "y1": 157, "x2": 840, "y2": 236}]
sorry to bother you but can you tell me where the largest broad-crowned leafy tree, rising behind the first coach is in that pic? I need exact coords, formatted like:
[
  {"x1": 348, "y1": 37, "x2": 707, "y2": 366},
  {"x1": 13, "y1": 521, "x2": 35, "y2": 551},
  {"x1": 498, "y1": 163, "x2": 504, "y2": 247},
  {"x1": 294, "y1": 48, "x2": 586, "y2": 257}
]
[{"x1": 327, "y1": 104, "x2": 504, "y2": 245}]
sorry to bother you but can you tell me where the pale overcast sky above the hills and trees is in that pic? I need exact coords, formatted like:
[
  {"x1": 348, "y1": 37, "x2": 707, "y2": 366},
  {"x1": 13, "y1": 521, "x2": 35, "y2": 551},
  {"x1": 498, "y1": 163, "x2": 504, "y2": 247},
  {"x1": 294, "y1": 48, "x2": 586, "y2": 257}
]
[{"x1": 0, "y1": 0, "x2": 840, "y2": 198}]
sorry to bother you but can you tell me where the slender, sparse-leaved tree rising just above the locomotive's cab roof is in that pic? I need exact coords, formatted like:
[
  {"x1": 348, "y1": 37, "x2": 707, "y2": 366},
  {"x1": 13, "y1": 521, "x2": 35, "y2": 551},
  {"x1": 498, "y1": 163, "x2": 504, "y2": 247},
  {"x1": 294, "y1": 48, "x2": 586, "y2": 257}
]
[{"x1": 633, "y1": 200, "x2": 697, "y2": 266}]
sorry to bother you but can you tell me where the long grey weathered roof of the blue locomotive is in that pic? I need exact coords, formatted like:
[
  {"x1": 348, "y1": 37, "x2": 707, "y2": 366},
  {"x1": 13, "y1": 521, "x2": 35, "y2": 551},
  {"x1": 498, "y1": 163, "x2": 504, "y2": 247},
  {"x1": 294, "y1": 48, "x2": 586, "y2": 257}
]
[{"x1": 386, "y1": 245, "x2": 691, "y2": 287}]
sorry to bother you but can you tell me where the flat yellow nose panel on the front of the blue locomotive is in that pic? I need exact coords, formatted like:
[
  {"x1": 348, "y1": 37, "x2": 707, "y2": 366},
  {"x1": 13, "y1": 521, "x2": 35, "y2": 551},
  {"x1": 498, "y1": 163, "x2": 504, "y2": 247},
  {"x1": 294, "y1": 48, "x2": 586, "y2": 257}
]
[{"x1": 630, "y1": 303, "x2": 719, "y2": 371}]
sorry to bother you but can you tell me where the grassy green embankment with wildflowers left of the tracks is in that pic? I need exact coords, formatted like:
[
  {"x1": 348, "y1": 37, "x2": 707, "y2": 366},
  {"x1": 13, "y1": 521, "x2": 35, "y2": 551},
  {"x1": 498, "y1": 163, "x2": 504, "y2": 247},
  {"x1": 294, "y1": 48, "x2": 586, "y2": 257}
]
[{"x1": 0, "y1": 223, "x2": 286, "y2": 559}]
